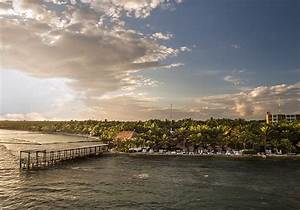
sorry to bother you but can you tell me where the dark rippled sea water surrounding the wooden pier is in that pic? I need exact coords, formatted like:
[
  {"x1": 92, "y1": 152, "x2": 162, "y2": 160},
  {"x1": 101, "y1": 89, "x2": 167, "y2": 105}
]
[{"x1": 0, "y1": 130, "x2": 300, "y2": 209}]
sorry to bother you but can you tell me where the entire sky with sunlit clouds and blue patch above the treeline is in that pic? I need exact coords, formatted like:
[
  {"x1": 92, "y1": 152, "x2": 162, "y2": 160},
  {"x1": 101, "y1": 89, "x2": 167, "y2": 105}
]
[{"x1": 0, "y1": 0, "x2": 300, "y2": 120}]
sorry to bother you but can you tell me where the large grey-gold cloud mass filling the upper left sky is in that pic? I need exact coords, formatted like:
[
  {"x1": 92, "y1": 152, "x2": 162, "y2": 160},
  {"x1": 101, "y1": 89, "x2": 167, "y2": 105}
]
[{"x1": 0, "y1": 0, "x2": 185, "y2": 99}]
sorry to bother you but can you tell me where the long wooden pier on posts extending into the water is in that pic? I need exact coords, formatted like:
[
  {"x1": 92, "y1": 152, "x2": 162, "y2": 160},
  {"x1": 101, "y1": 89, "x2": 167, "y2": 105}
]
[{"x1": 20, "y1": 144, "x2": 108, "y2": 169}]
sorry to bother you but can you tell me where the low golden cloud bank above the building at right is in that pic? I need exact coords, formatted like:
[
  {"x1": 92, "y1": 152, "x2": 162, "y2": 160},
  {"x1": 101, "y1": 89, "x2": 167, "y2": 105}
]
[{"x1": 196, "y1": 83, "x2": 300, "y2": 119}]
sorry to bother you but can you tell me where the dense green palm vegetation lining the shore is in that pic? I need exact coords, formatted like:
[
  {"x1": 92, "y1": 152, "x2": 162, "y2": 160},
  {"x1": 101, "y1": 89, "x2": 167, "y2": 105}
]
[{"x1": 0, "y1": 119, "x2": 300, "y2": 153}]
